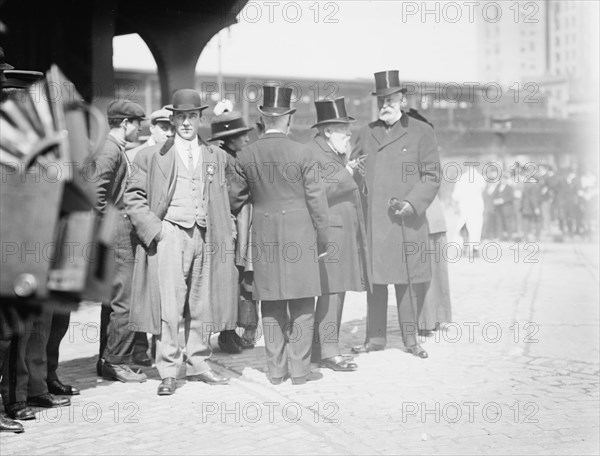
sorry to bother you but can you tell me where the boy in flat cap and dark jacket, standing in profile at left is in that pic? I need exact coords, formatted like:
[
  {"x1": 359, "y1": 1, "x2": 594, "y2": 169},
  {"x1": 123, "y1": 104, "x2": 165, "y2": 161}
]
[{"x1": 93, "y1": 100, "x2": 146, "y2": 382}]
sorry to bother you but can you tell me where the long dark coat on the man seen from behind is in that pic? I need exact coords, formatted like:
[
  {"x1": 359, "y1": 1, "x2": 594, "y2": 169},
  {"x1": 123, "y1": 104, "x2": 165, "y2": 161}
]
[{"x1": 230, "y1": 133, "x2": 328, "y2": 301}]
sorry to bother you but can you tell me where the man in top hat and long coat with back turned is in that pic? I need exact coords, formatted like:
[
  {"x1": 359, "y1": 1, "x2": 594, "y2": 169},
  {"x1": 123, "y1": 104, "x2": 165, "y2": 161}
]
[{"x1": 230, "y1": 85, "x2": 328, "y2": 384}]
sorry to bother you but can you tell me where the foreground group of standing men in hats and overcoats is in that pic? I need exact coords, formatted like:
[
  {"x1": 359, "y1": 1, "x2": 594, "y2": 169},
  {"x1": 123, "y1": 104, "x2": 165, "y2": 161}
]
[{"x1": 1, "y1": 66, "x2": 451, "y2": 432}]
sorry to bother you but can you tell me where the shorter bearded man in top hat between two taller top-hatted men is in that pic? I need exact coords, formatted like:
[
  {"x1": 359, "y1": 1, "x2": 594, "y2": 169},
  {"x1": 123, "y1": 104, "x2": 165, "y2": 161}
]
[{"x1": 308, "y1": 97, "x2": 368, "y2": 371}]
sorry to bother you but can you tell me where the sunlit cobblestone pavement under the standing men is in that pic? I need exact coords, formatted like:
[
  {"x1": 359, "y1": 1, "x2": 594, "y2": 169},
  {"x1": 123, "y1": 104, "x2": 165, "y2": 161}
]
[{"x1": 0, "y1": 243, "x2": 599, "y2": 456}]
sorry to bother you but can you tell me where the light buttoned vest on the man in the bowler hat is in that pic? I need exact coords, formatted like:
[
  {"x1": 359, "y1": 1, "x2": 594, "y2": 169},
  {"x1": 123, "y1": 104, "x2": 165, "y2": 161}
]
[{"x1": 165, "y1": 150, "x2": 206, "y2": 228}]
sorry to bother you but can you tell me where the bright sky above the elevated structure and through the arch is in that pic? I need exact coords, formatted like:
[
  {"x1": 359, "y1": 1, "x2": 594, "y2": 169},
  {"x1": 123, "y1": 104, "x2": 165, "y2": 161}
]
[{"x1": 113, "y1": 0, "x2": 482, "y2": 81}]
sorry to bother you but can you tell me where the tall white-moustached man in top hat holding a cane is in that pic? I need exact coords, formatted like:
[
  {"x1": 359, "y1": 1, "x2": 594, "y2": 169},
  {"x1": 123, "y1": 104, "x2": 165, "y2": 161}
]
[{"x1": 352, "y1": 71, "x2": 440, "y2": 358}]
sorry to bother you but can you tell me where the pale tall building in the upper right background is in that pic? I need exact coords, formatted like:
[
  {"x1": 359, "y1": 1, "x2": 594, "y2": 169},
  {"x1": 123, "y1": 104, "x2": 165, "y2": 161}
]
[{"x1": 478, "y1": 0, "x2": 599, "y2": 118}]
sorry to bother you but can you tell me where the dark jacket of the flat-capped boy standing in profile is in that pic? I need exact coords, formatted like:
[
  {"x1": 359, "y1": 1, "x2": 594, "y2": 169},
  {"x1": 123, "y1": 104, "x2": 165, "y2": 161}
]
[{"x1": 92, "y1": 135, "x2": 127, "y2": 213}]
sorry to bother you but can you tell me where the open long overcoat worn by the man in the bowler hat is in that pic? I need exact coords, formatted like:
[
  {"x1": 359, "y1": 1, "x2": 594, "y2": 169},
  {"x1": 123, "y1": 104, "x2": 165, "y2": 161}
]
[{"x1": 124, "y1": 139, "x2": 238, "y2": 334}]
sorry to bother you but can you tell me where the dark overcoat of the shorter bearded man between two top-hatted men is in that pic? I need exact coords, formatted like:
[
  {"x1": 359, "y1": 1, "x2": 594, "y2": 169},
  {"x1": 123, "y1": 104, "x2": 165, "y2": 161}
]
[{"x1": 307, "y1": 135, "x2": 369, "y2": 294}]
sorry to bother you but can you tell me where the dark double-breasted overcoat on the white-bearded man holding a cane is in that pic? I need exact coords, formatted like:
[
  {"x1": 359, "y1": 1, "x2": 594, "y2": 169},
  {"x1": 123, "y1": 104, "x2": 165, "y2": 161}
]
[{"x1": 352, "y1": 114, "x2": 440, "y2": 284}]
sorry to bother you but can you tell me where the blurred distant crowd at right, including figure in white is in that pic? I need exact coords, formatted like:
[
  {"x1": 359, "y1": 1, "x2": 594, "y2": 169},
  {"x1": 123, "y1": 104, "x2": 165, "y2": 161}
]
[{"x1": 445, "y1": 162, "x2": 598, "y2": 255}]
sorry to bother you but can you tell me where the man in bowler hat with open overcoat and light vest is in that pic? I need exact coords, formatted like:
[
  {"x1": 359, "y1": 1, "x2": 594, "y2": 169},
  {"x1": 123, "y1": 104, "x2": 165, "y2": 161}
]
[{"x1": 125, "y1": 89, "x2": 237, "y2": 395}]
